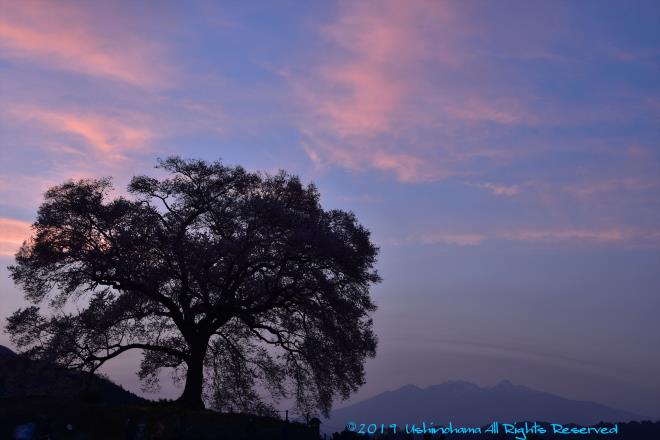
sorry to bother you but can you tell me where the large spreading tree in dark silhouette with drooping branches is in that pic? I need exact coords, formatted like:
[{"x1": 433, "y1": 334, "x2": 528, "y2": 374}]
[{"x1": 7, "y1": 157, "x2": 379, "y2": 414}]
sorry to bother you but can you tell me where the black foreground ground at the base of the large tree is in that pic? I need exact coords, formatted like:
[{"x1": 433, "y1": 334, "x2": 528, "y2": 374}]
[{"x1": 0, "y1": 396, "x2": 319, "y2": 440}]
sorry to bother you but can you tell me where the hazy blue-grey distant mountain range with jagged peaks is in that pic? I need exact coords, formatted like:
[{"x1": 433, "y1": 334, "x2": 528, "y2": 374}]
[{"x1": 328, "y1": 380, "x2": 643, "y2": 426}]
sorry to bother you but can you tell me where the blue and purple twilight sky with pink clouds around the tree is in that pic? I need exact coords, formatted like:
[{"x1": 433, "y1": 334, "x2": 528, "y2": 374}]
[{"x1": 0, "y1": 0, "x2": 660, "y2": 418}]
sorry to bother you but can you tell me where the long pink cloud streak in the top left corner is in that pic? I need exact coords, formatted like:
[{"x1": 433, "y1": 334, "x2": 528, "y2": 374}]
[{"x1": 0, "y1": 0, "x2": 172, "y2": 87}]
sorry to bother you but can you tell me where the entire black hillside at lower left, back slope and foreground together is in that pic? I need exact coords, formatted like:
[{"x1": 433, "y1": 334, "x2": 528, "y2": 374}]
[{"x1": 0, "y1": 346, "x2": 319, "y2": 440}]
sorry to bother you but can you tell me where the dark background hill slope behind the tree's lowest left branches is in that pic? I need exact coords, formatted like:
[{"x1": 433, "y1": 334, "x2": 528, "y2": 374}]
[{"x1": 0, "y1": 345, "x2": 146, "y2": 404}]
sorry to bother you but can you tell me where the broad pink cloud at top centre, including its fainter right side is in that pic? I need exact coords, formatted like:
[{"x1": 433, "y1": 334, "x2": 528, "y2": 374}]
[{"x1": 296, "y1": 1, "x2": 538, "y2": 182}]
